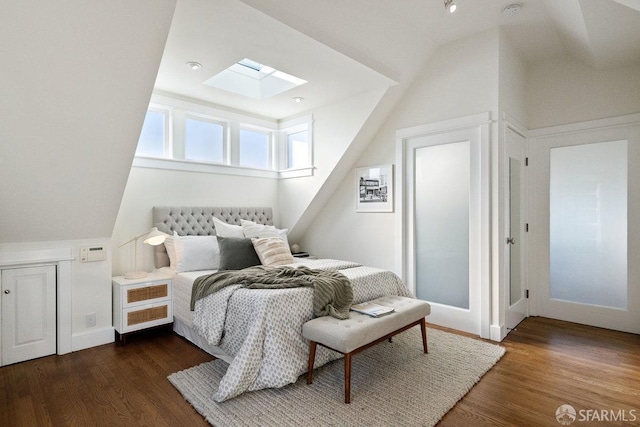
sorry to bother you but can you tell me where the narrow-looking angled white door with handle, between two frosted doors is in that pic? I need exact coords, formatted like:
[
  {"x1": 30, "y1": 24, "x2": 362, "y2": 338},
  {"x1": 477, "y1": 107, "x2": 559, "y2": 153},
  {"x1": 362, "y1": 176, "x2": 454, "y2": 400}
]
[{"x1": 502, "y1": 128, "x2": 528, "y2": 332}]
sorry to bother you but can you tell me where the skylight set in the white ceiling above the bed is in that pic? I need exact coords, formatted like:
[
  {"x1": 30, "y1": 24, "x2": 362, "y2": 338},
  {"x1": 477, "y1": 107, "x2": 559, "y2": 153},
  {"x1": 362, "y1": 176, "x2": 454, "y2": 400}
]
[{"x1": 204, "y1": 58, "x2": 307, "y2": 99}]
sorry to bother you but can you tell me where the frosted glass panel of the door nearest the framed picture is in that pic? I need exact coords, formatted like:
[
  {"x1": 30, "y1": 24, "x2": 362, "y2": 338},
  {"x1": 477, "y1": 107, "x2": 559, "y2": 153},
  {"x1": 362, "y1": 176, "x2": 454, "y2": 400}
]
[{"x1": 415, "y1": 141, "x2": 470, "y2": 309}]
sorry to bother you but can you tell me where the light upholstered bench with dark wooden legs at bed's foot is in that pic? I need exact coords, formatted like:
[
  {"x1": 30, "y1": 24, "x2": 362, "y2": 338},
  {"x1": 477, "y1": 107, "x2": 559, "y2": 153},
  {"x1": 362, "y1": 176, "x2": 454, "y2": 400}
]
[{"x1": 302, "y1": 295, "x2": 431, "y2": 403}]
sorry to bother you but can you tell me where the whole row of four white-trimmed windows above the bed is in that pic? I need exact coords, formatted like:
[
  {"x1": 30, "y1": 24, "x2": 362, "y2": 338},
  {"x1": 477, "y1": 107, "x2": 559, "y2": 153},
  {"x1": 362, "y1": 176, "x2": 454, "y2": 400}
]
[{"x1": 133, "y1": 95, "x2": 313, "y2": 179}]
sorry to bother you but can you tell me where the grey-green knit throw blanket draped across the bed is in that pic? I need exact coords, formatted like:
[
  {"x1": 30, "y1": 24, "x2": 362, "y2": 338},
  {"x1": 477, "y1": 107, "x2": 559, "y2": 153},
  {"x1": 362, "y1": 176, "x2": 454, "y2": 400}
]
[{"x1": 191, "y1": 265, "x2": 353, "y2": 319}]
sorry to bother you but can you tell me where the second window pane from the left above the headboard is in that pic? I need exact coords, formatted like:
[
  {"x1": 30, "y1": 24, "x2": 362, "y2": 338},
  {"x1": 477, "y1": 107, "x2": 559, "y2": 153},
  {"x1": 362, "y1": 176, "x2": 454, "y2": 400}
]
[{"x1": 184, "y1": 117, "x2": 225, "y2": 163}]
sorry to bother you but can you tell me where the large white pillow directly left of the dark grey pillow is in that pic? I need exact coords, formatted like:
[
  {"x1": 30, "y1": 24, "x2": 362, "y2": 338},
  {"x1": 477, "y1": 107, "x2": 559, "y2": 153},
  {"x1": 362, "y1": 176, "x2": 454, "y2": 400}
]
[{"x1": 170, "y1": 233, "x2": 220, "y2": 273}]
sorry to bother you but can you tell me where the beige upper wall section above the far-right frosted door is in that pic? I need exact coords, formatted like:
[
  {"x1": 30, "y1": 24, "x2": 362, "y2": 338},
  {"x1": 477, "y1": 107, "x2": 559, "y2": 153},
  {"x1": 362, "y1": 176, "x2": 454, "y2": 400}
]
[{"x1": 526, "y1": 58, "x2": 640, "y2": 129}]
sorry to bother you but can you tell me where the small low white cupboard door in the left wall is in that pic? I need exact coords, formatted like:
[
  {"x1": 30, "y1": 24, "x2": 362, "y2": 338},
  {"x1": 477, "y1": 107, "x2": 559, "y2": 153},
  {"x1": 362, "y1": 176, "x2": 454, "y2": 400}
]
[{"x1": 0, "y1": 265, "x2": 56, "y2": 365}]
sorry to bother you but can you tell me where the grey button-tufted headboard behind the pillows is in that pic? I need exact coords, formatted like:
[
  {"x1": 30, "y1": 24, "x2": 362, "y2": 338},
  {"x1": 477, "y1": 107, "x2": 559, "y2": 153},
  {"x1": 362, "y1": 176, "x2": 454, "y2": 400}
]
[{"x1": 152, "y1": 206, "x2": 273, "y2": 268}]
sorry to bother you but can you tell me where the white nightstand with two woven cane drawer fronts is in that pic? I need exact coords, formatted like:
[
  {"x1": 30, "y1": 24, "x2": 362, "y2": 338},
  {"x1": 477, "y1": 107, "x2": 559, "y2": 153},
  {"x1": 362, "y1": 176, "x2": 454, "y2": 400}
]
[{"x1": 111, "y1": 272, "x2": 173, "y2": 344}]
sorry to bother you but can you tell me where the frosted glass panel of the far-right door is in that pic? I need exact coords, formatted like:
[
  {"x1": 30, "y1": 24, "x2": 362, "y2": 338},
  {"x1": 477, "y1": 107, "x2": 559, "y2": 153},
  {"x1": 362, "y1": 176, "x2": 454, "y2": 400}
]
[{"x1": 549, "y1": 141, "x2": 627, "y2": 309}]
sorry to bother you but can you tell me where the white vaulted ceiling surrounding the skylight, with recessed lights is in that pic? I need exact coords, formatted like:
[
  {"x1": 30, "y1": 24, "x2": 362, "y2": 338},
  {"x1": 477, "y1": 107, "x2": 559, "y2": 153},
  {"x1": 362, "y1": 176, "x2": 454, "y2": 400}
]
[{"x1": 155, "y1": 0, "x2": 640, "y2": 119}]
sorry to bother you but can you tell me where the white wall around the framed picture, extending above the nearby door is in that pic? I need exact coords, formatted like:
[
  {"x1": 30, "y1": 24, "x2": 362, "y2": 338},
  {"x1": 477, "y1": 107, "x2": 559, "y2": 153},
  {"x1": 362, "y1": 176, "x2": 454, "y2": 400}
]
[{"x1": 301, "y1": 29, "x2": 499, "y2": 271}]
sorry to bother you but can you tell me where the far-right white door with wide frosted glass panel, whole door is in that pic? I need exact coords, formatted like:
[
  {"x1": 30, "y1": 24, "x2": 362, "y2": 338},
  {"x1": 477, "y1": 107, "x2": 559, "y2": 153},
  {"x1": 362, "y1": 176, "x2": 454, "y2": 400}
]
[{"x1": 528, "y1": 124, "x2": 640, "y2": 333}]
